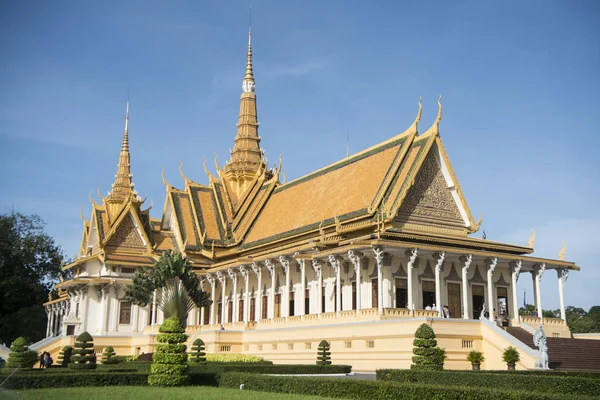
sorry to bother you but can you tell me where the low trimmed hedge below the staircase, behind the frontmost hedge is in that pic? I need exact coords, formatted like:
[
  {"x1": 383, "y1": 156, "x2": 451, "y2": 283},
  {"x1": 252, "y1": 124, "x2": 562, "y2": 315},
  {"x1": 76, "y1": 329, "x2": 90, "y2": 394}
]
[{"x1": 377, "y1": 369, "x2": 600, "y2": 396}]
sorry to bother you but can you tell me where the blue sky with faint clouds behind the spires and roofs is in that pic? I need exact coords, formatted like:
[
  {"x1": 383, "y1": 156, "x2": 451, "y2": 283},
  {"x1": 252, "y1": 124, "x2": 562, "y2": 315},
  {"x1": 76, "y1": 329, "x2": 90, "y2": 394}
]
[{"x1": 0, "y1": 0, "x2": 600, "y2": 309}]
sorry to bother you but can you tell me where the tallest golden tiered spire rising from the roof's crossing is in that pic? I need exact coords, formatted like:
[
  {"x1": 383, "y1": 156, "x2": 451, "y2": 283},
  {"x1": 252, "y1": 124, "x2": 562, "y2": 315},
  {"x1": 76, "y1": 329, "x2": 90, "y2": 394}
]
[{"x1": 223, "y1": 27, "x2": 264, "y2": 195}]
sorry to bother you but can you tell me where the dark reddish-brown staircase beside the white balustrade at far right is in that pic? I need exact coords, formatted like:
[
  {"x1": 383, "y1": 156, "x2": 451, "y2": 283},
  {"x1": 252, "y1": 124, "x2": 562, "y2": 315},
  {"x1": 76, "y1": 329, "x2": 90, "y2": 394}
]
[{"x1": 506, "y1": 327, "x2": 600, "y2": 371}]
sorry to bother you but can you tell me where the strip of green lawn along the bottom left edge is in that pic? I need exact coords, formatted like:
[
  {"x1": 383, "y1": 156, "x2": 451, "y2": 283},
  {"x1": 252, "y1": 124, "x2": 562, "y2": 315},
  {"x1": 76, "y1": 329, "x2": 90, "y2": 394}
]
[{"x1": 0, "y1": 386, "x2": 332, "y2": 400}]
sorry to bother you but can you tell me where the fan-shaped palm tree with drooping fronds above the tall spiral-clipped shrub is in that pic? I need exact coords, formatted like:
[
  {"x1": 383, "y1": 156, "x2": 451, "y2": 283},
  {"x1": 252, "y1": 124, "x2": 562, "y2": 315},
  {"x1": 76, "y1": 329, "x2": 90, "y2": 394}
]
[{"x1": 125, "y1": 250, "x2": 211, "y2": 326}]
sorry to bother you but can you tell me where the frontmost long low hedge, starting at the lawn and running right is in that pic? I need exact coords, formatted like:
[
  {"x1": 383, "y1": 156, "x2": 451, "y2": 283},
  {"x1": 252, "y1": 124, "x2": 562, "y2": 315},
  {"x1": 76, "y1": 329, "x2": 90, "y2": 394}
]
[{"x1": 219, "y1": 372, "x2": 589, "y2": 400}]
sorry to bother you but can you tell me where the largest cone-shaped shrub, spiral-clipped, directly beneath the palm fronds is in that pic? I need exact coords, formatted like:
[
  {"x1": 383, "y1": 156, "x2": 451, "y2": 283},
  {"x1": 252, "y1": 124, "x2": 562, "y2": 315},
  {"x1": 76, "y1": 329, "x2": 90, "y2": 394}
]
[{"x1": 148, "y1": 316, "x2": 189, "y2": 386}]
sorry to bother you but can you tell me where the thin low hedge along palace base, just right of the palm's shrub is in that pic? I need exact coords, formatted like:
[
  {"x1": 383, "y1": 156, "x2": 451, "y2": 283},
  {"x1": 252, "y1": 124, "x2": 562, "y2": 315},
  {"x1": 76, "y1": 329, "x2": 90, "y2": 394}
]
[{"x1": 190, "y1": 364, "x2": 352, "y2": 375}]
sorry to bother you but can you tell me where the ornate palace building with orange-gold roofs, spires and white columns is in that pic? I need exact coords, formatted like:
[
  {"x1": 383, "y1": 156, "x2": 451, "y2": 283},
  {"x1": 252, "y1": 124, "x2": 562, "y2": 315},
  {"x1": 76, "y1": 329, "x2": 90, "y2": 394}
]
[{"x1": 34, "y1": 29, "x2": 579, "y2": 371}]
